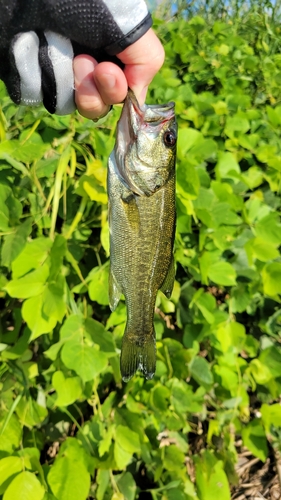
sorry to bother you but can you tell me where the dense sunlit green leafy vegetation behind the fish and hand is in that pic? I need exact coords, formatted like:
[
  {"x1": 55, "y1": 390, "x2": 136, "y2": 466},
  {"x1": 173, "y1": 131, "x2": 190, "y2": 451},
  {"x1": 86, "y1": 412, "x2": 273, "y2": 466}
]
[{"x1": 0, "y1": 0, "x2": 281, "y2": 500}]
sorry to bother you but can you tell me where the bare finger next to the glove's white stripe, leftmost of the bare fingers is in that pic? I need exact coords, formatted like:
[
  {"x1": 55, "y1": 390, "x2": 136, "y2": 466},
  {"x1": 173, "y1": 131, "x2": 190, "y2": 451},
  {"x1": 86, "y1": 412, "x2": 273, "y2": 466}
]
[{"x1": 73, "y1": 55, "x2": 109, "y2": 119}]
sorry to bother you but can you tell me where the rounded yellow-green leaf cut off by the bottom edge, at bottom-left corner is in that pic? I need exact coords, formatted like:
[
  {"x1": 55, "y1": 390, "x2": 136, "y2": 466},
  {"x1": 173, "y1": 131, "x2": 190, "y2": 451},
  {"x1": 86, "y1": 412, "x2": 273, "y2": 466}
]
[{"x1": 3, "y1": 471, "x2": 45, "y2": 500}]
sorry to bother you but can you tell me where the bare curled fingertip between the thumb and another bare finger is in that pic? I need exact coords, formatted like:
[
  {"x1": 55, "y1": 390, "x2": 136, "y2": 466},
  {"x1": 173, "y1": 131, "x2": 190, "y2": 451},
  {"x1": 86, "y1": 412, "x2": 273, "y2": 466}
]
[{"x1": 94, "y1": 62, "x2": 128, "y2": 105}]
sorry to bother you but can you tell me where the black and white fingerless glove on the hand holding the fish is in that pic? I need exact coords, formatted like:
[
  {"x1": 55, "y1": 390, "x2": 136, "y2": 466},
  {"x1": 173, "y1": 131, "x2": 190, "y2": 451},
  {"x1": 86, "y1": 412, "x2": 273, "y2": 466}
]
[{"x1": 0, "y1": 0, "x2": 152, "y2": 115}]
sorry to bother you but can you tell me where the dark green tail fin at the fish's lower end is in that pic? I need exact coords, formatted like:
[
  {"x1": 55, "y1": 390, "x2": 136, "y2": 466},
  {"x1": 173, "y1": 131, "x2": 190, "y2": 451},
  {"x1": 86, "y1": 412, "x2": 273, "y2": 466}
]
[{"x1": 120, "y1": 330, "x2": 156, "y2": 382}]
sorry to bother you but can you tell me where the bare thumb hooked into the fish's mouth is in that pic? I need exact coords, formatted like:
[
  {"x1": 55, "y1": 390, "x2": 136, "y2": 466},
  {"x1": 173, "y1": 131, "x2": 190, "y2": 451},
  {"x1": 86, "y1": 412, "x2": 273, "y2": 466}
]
[{"x1": 117, "y1": 29, "x2": 165, "y2": 105}]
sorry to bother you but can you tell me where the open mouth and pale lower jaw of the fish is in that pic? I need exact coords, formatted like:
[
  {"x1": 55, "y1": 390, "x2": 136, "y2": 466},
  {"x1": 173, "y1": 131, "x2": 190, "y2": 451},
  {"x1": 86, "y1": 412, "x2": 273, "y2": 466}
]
[{"x1": 115, "y1": 89, "x2": 175, "y2": 196}]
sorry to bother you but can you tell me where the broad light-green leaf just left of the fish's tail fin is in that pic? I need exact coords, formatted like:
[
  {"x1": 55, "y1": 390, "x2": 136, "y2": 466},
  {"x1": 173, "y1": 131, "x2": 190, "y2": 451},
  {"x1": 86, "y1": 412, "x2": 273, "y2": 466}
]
[{"x1": 61, "y1": 340, "x2": 107, "y2": 382}]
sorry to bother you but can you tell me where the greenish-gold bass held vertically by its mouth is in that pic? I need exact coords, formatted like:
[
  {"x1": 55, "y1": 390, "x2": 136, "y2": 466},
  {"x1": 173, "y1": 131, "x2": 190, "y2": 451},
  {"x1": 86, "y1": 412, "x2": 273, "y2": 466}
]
[{"x1": 107, "y1": 89, "x2": 177, "y2": 382}]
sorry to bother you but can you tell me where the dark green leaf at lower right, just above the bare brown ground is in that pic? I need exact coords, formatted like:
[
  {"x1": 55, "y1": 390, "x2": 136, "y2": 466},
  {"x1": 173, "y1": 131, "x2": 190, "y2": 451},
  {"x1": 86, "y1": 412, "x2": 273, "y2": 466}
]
[{"x1": 242, "y1": 418, "x2": 268, "y2": 462}]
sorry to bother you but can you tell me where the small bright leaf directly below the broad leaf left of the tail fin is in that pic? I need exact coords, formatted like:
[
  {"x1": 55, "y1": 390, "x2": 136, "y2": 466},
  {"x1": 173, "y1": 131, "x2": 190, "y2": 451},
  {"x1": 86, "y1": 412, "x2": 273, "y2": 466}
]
[{"x1": 52, "y1": 372, "x2": 82, "y2": 406}]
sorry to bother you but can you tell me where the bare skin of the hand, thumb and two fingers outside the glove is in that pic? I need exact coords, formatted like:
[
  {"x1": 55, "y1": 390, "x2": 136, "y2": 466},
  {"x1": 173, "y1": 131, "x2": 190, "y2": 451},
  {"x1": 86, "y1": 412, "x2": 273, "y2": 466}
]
[{"x1": 73, "y1": 29, "x2": 165, "y2": 119}]
